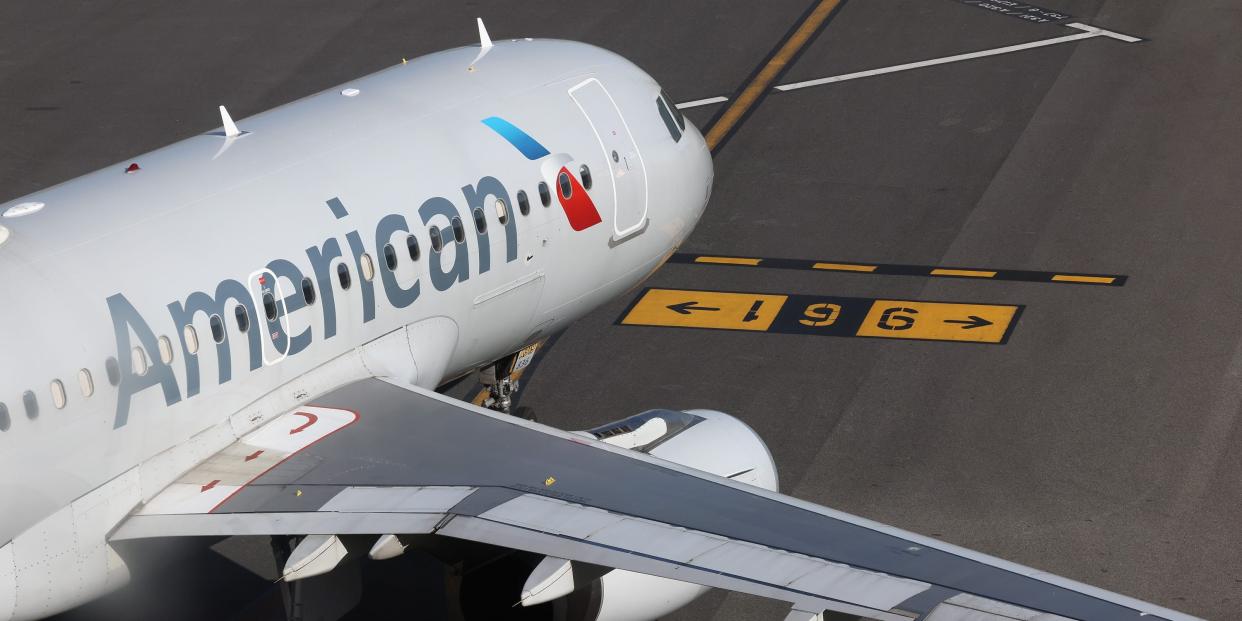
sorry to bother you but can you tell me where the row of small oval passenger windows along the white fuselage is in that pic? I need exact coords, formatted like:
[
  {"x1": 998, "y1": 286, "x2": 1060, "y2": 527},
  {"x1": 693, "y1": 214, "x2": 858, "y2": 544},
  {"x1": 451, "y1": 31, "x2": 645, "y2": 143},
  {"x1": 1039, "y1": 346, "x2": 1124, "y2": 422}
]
[{"x1": 0, "y1": 164, "x2": 592, "y2": 432}]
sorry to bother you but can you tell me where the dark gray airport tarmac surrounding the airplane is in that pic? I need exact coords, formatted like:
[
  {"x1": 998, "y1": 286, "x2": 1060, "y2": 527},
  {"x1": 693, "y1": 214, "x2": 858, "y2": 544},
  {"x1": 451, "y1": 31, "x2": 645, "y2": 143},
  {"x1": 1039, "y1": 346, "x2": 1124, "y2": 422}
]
[{"x1": 0, "y1": 0, "x2": 1242, "y2": 620}]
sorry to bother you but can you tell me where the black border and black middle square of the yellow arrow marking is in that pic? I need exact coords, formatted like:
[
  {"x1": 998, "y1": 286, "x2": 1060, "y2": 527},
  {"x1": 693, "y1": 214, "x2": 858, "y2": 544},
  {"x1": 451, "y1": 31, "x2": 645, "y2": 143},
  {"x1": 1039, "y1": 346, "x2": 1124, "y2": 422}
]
[{"x1": 612, "y1": 287, "x2": 1026, "y2": 345}]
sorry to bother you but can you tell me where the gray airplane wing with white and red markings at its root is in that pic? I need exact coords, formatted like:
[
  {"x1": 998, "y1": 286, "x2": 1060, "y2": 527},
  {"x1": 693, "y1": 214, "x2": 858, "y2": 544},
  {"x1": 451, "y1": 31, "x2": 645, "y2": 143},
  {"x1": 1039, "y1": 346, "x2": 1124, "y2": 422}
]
[{"x1": 113, "y1": 379, "x2": 1195, "y2": 621}]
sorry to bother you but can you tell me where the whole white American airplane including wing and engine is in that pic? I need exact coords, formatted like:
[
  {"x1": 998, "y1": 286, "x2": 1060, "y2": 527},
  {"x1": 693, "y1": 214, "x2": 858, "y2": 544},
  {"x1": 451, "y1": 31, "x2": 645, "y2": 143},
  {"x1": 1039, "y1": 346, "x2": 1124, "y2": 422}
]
[{"x1": 0, "y1": 16, "x2": 1195, "y2": 621}]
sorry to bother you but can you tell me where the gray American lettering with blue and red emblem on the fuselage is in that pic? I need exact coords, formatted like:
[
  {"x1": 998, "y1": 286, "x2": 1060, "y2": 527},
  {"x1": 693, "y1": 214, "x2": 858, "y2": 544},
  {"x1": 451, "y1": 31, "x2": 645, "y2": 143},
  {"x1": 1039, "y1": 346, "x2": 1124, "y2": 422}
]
[{"x1": 107, "y1": 117, "x2": 601, "y2": 428}]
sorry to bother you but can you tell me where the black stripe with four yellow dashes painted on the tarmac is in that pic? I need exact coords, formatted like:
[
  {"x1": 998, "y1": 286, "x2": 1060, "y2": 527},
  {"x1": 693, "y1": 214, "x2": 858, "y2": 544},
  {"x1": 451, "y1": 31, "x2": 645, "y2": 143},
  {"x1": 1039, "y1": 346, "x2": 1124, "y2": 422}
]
[{"x1": 668, "y1": 252, "x2": 1129, "y2": 287}]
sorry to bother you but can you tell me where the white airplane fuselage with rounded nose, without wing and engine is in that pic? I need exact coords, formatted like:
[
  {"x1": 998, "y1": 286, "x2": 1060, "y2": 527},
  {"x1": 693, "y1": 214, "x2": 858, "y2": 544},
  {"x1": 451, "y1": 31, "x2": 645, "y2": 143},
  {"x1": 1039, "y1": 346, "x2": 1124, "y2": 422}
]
[{"x1": 0, "y1": 41, "x2": 712, "y2": 620}]
